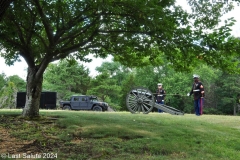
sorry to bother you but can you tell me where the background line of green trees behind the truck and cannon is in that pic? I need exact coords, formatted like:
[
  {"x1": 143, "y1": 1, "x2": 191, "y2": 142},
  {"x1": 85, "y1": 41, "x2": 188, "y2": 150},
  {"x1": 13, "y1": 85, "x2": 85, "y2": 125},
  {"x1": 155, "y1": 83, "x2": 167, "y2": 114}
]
[{"x1": 0, "y1": 60, "x2": 240, "y2": 115}]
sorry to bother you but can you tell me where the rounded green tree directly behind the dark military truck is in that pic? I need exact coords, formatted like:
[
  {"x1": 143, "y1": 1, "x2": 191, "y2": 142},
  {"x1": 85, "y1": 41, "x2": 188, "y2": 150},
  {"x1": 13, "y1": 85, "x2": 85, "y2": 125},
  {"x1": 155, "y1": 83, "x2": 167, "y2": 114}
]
[{"x1": 43, "y1": 60, "x2": 90, "y2": 99}]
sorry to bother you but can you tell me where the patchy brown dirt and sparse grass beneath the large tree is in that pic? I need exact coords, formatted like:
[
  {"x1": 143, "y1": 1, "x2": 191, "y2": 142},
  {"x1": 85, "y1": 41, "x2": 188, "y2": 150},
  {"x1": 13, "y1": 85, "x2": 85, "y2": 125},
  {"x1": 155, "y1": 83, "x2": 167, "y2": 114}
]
[{"x1": 0, "y1": 115, "x2": 104, "y2": 160}]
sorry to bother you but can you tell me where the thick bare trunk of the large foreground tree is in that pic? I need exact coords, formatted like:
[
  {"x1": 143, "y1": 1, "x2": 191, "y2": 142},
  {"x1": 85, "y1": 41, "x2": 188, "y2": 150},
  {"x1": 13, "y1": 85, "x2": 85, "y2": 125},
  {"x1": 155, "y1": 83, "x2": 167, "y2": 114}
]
[{"x1": 22, "y1": 67, "x2": 43, "y2": 117}]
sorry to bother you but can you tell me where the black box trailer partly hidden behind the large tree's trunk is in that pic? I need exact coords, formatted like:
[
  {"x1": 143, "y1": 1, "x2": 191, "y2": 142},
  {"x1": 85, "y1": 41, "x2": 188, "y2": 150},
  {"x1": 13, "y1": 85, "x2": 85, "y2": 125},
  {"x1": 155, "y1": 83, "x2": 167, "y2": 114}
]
[{"x1": 16, "y1": 92, "x2": 57, "y2": 109}]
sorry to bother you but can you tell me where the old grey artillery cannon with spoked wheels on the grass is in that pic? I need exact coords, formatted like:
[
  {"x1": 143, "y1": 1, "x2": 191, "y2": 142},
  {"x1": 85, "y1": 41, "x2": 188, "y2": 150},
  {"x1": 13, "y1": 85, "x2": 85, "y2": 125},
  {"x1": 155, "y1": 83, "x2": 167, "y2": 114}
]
[{"x1": 126, "y1": 87, "x2": 184, "y2": 115}]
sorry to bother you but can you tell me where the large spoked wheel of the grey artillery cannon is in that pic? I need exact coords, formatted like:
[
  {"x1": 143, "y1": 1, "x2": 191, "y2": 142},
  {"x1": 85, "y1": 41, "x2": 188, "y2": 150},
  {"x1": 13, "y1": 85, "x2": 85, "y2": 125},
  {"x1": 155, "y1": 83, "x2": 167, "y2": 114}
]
[{"x1": 126, "y1": 88, "x2": 154, "y2": 114}]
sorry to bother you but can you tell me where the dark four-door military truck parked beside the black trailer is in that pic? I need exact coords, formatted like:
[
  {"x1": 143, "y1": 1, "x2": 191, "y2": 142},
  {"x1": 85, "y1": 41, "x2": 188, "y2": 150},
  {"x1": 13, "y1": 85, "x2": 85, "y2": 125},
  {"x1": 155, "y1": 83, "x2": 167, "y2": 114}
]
[{"x1": 59, "y1": 95, "x2": 108, "y2": 111}]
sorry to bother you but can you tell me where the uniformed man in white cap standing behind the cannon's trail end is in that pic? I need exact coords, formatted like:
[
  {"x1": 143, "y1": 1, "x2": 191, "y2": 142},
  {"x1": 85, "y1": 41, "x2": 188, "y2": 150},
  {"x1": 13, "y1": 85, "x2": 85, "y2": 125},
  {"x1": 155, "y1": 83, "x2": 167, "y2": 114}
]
[{"x1": 188, "y1": 74, "x2": 204, "y2": 116}]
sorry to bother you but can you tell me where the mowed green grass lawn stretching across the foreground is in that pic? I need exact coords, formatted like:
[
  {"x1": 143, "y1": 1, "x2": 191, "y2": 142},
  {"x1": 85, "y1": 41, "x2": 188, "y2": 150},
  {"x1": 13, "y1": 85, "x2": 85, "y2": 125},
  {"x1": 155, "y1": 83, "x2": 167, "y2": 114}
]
[{"x1": 0, "y1": 110, "x2": 240, "y2": 160}]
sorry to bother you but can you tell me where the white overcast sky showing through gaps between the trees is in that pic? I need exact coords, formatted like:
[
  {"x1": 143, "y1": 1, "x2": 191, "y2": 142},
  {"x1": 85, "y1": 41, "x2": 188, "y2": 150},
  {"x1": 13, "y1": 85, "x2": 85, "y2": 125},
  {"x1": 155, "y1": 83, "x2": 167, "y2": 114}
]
[{"x1": 0, "y1": 0, "x2": 240, "y2": 80}]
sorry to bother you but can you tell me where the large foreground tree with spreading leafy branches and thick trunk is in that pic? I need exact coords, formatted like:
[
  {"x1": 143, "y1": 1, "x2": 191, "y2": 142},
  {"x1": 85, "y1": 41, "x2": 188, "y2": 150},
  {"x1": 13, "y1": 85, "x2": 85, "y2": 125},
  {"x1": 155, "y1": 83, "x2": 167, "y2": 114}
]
[{"x1": 0, "y1": 0, "x2": 239, "y2": 117}]
